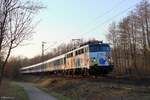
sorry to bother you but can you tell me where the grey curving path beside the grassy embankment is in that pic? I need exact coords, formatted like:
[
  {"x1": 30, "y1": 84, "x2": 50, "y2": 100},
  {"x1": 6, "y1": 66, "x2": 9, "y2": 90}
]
[{"x1": 18, "y1": 83, "x2": 57, "y2": 100}]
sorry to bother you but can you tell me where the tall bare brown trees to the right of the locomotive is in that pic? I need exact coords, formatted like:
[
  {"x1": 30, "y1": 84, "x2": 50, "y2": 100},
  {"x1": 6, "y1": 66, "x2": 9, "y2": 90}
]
[{"x1": 106, "y1": 0, "x2": 150, "y2": 77}]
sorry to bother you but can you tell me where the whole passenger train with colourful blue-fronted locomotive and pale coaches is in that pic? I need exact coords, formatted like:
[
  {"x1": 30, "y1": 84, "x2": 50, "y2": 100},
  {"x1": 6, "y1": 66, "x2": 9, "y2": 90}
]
[{"x1": 20, "y1": 41, "x2": 114, "y2": 75}]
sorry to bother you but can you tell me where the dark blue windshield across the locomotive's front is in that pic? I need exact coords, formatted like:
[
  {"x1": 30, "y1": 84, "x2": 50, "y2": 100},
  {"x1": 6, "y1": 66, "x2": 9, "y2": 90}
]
[{"x1": 89, "y1": 44, "x2": 110, "y2": 52}]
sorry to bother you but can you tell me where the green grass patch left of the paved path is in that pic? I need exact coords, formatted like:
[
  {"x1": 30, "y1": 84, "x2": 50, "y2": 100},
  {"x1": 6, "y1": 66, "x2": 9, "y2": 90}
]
[{"x1": 0, "y1": 80, "x2": 28, "y2": 100}]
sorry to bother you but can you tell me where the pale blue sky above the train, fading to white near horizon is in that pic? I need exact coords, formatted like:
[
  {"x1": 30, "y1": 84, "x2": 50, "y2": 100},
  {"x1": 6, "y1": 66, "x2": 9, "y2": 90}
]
[{"x1": 12, "y1": 0, "x2": 141, "y2": 58}]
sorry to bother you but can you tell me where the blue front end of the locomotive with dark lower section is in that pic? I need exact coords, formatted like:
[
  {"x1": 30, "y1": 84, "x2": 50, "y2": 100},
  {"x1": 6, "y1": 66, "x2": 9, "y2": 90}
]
[{"x1": 89, "y1": 43, "x2": 113, "y2": 75}]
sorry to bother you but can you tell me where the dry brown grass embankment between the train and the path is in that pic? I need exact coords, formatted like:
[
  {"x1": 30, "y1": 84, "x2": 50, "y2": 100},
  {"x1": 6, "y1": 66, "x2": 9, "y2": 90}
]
[{"x1": 23, "y1": 78, "x2": 150, "y2": 100}]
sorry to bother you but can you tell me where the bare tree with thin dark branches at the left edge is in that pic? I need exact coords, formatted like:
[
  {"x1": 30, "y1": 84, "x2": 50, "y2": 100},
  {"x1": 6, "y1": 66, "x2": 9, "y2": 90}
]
[{"x1": 0, "y1": 0, "x2": 42, "y2": 84}]
